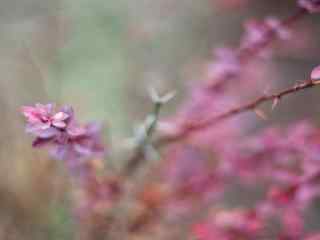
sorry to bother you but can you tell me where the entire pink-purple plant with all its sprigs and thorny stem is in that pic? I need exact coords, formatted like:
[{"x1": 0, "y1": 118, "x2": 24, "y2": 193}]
[{"x1": 22, "y1": 0, "x2": 320, "y2": 240}]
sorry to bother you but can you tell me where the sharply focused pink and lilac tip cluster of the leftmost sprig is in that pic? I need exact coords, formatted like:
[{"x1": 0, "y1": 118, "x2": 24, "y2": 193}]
[{"x1": 22, "y1": 104, "x2": 105, "y2": 172}]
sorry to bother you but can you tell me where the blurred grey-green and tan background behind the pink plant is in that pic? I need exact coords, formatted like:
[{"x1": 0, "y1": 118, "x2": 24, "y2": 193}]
[{"x1": 0, "y1": 0, "x2": 320, "y2": 240}]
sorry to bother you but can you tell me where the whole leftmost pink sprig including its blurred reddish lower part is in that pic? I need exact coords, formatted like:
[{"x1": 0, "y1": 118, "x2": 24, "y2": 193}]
[{"x1": 21, "y1": 104, "x2": 121, "y2": 231}]
